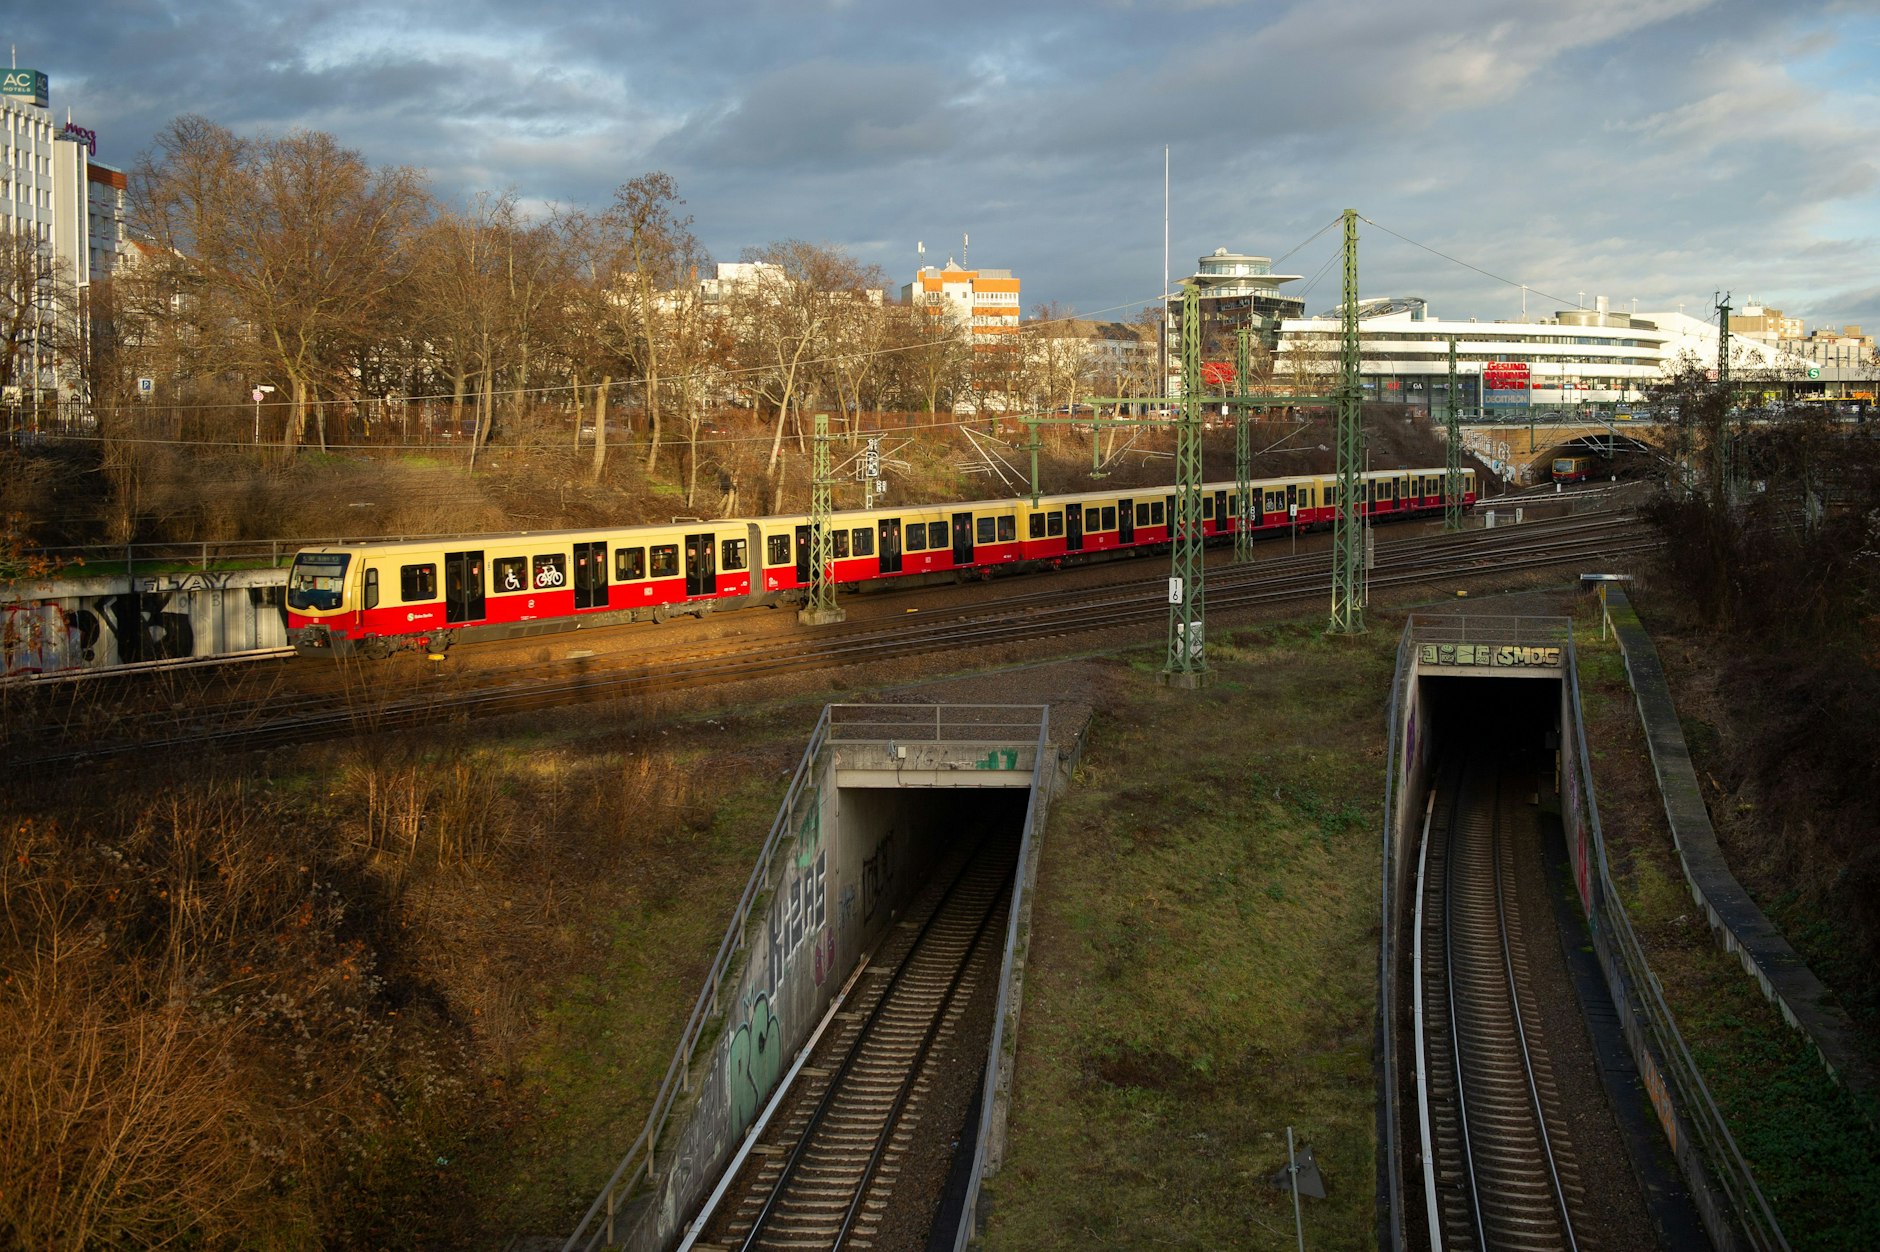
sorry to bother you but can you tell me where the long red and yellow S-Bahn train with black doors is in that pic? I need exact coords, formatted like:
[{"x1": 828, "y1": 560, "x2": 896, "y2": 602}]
[{"x1": 288, "y1": 458, "x2": 1476, "y2": 656}]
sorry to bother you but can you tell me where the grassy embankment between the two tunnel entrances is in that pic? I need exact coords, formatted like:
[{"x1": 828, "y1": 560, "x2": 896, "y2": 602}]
[{"x1": 987, "y1": 622, "x2": 1397, "y2": 1250}]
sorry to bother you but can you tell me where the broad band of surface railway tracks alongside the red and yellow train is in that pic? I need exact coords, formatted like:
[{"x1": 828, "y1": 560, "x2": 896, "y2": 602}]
[{"x1": 0, "y1": 511, "x2": 1658, "y2": 765}]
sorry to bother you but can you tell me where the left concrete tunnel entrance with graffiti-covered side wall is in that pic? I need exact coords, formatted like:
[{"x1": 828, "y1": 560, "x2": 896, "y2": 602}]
[{"x1": 583, "y1": 705, "x2": 1058, "y2": 1250}]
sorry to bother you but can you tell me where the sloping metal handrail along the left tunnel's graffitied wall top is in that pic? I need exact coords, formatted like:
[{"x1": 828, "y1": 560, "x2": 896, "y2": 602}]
[{"x1": 562, "y1": 707, "x2": 831, "y2": 1252}]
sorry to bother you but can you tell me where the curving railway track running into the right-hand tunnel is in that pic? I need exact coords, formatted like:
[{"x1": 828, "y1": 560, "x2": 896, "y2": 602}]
[{"x1": 1416, "y1": 755, "x2": 1589, "y2": 1252}]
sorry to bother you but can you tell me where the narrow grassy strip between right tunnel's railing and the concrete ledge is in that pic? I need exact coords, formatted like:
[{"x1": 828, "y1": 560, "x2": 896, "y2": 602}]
[{"x1": 1577, "y1": 616, "x2": 1880, "y2": 1252}]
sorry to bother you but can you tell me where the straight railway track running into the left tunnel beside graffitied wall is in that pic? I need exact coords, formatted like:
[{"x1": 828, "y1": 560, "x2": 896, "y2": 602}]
[{"x1": 681, "y1": 835, "x2": 1017, "y2": 1252}]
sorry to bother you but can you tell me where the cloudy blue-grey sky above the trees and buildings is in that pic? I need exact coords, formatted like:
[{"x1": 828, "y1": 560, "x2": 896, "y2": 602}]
[{"x1": 14, "y1": 0, "x2": 1880, "y2": 333}]
